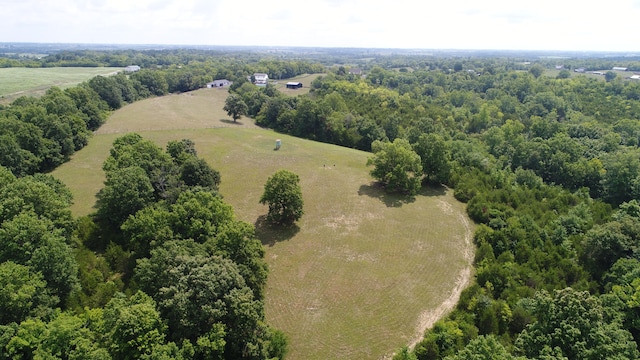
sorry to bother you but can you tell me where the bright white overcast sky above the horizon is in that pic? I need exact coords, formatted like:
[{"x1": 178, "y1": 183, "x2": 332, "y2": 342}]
[{"x1": 0, "y1": 0, "x2": 640, "y2": 52}]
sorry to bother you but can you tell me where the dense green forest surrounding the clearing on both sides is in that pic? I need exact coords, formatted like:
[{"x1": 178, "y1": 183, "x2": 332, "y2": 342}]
[{"x1": 0, "y1": 50, "x2": 640, "y2": 359}]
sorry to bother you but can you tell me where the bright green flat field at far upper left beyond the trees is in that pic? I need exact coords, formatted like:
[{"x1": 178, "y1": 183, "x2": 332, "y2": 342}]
[{"x1": 0, "y1": 67, "x2": 122, "y2": 103}]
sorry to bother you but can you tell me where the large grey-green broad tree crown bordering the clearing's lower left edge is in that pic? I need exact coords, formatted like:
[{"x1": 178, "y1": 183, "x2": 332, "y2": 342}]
[{"x1": 136, "y1": 241, "x2": 266, "y2": 358}]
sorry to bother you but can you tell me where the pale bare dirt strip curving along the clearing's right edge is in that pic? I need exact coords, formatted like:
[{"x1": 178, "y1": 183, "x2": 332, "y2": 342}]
[{"x1": 408, "y1": 204, "x2": 473, "y2": 350}]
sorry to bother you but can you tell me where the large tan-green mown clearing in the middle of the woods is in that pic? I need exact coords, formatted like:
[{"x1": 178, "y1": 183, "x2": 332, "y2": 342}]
[{"x1": 53, "y1": 89, "x2": 473, "y2": 359}]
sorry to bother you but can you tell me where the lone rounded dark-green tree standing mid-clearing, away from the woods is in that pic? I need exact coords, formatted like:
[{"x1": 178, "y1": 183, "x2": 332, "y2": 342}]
[{"x1": 260, "y1": 170, "x2": 304, "y2": 225}]
